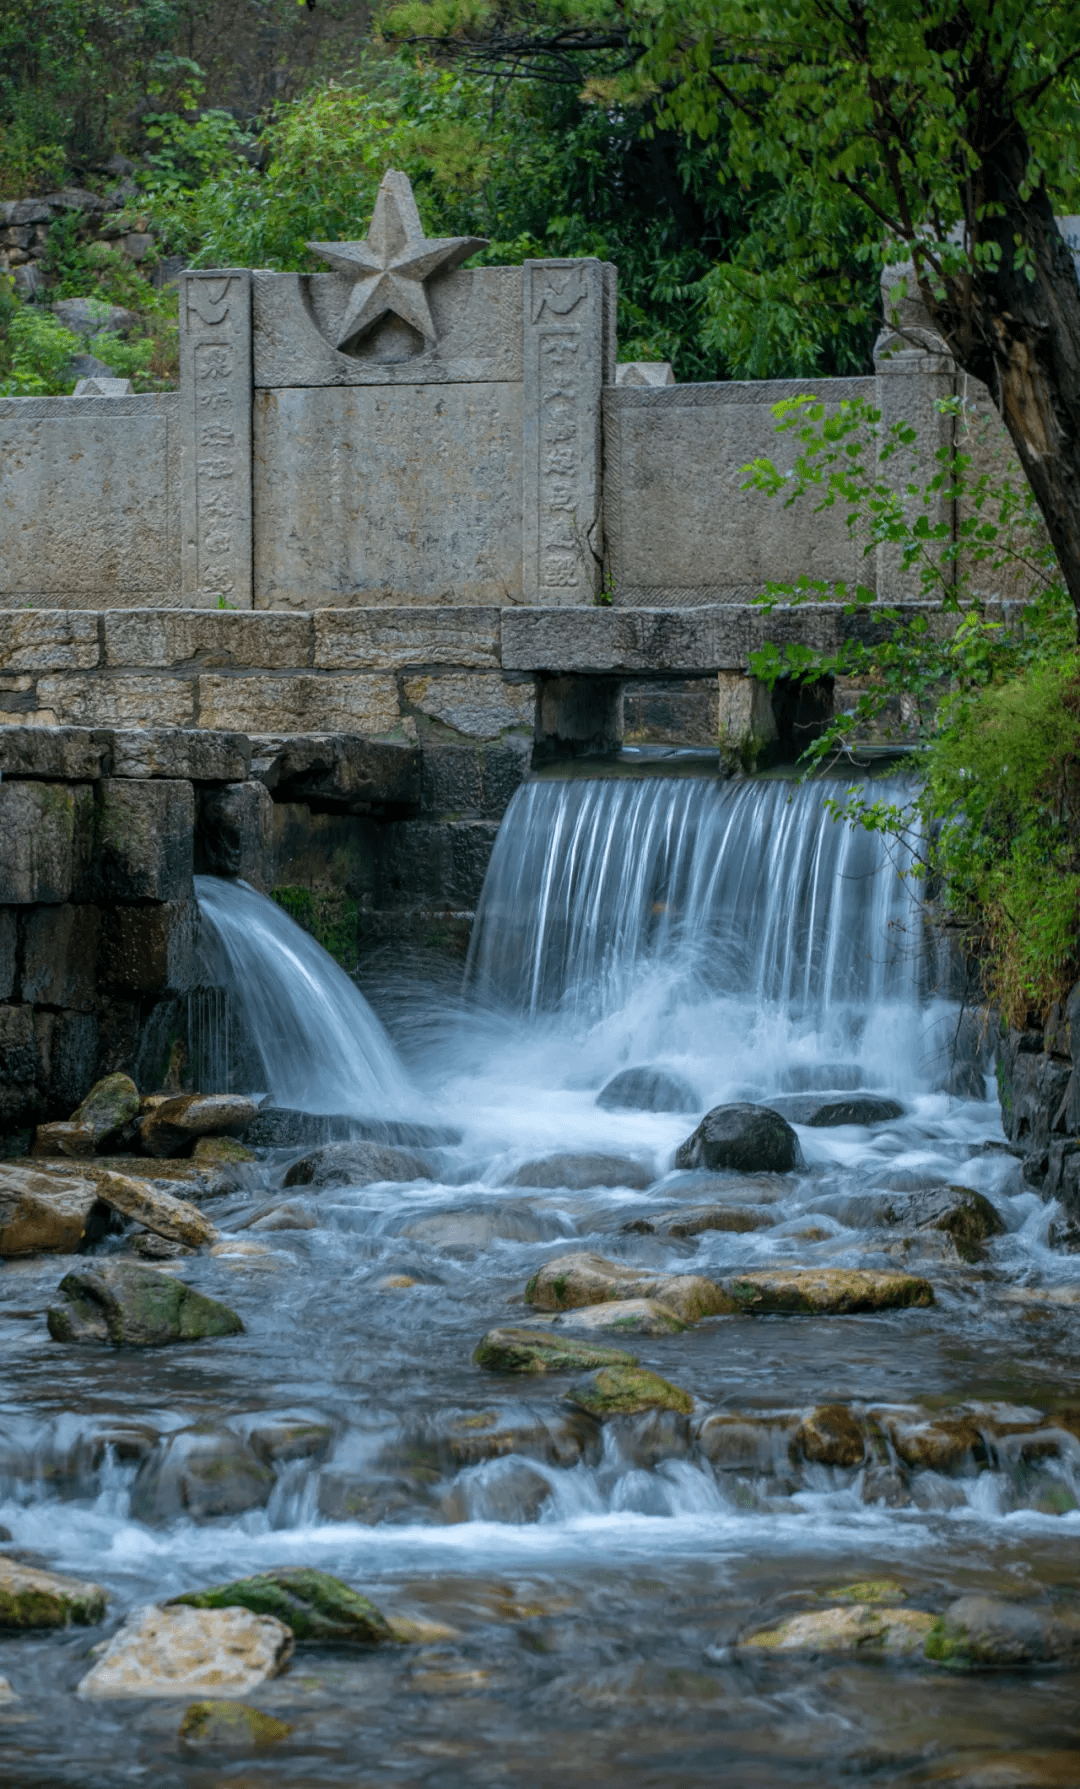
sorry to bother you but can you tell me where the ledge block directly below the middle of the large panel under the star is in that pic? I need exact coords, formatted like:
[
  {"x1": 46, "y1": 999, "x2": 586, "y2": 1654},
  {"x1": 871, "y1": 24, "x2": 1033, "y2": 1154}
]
[{"x1": 313, "y1": 608, "x2": 499, "y2": 671}]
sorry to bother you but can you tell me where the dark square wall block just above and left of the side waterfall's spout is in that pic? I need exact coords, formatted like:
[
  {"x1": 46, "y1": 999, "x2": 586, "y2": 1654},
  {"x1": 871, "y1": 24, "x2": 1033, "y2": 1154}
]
[{"x1": 95, "y1": 776, "x2": 195, "y2": 902}]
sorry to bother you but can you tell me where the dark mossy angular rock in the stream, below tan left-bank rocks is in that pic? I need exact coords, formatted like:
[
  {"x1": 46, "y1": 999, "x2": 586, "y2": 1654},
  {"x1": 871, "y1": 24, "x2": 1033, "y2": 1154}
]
[{"x1": 48, "y1": 1261, "x2": 243, "y2": 1347}]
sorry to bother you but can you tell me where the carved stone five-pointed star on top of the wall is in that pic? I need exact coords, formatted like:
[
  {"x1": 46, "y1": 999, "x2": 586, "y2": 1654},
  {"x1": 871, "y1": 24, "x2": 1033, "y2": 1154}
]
[{"x1": 308, "y1": 168, "x2": 488, "y2": 349}]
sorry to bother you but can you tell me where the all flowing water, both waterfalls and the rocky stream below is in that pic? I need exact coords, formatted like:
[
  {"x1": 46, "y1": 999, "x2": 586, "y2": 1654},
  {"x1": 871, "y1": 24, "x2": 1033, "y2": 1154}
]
[{"x1": 0, "y1": 776, "x2": 1080, "y2": 1789}]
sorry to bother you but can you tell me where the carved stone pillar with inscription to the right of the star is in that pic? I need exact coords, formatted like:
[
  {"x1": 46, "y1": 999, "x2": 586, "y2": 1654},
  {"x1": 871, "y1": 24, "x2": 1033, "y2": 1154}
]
[{"x1": 522, "y1": 261, "x2": 613, "y2": 606}]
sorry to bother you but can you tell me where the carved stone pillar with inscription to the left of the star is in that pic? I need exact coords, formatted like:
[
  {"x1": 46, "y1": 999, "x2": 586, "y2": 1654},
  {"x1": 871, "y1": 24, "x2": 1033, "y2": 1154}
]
[{"x1": 181, "y1": 268, "x2": 252, "y2": 608}]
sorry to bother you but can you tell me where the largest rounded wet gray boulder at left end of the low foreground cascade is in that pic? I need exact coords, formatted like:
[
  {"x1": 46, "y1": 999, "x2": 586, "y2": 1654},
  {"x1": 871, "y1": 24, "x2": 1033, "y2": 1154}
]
[{"x1": 131, "y1": 1428, "x2": 275, "y2": 1522}]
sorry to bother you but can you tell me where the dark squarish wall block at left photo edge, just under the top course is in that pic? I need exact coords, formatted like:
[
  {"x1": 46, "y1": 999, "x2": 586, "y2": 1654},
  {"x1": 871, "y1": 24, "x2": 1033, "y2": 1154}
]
[{"x1": 0, "y1": 782, "x2": 93, "y2": 907}]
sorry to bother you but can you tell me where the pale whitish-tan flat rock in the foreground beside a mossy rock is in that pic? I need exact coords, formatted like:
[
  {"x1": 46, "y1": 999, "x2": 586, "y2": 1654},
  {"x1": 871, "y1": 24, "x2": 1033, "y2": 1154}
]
[{"x1": 75, "y1": 1603, "x2": 293, "y2": 1698}]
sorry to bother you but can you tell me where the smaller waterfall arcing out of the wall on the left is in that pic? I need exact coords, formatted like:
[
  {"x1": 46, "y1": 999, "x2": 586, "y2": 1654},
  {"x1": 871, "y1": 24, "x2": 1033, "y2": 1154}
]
[{"x1": 195, "y1": 877, "x2": 411, "y2": 1116}]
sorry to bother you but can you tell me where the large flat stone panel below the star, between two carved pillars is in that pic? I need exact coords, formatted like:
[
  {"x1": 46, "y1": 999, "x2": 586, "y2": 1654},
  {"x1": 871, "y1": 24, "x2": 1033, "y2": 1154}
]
[{"x1": 254, "y1": 383, "x2": 522, "y2": 608}]
